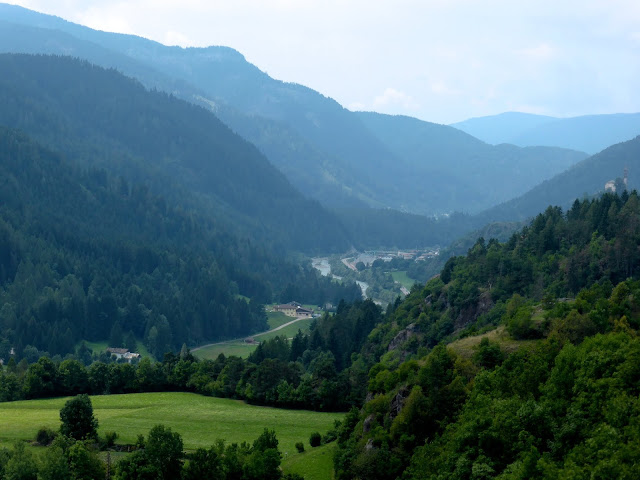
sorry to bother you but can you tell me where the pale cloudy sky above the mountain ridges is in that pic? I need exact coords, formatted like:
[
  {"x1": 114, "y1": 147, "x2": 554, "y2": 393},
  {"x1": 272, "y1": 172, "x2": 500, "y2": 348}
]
[{"x1": 0, "y1": 0, "x2": 640, "y2": 124}]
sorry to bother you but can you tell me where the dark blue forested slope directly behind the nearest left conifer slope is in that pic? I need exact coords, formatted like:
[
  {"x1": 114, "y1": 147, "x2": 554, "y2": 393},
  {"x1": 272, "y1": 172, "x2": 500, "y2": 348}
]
[{"x1": 0, "y1": 55, "x2": 349, "y2": 255}]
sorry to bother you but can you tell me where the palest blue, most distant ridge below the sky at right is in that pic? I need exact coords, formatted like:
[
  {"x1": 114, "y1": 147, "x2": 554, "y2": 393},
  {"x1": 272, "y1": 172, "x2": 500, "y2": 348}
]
[{"x1": 451, "y1": 112, "x2": 640, "y2": 154}]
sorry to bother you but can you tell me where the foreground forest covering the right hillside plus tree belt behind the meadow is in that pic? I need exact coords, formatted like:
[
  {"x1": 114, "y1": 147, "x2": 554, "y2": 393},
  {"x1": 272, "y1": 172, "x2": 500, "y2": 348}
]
[{"x1": 0, "y1": 179, "x2": 640, "y2": 479}]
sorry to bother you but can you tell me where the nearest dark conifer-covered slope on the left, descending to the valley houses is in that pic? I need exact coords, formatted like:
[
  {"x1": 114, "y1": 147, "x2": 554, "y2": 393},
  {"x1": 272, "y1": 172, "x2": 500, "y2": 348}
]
[{"x1": 0, "y1": 128, "x2": 360, "y2": 358}]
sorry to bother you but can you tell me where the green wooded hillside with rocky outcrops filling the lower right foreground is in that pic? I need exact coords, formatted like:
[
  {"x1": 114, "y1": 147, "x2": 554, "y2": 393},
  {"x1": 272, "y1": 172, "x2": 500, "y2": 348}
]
[{"x1": 335, "y1": 192, "x2": 640, "y2": 479}]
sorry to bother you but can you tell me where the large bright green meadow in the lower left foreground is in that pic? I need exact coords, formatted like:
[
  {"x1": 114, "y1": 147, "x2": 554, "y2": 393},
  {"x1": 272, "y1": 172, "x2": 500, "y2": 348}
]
[{"x1": 0, "y1": 393, "x2": 343, "y2": 459}]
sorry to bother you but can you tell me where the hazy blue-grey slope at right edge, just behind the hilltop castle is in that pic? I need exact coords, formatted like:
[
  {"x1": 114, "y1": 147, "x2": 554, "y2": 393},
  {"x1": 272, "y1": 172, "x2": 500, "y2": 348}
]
[{"x1": 473, "y1": 136, "x2": 640, "y2": 225}]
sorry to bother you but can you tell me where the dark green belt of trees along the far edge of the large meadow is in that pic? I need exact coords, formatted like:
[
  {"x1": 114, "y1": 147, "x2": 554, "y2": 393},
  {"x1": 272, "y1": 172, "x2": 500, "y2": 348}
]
[{"x1": 0, "y1": 300, "x2": 382, "y2": 411}]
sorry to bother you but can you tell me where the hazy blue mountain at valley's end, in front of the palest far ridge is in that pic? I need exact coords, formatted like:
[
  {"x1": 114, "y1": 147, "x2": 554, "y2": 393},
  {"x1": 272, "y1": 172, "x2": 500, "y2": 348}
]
[{"x1": 358, "y1": 112, "x2": 586, "y2": 213}]
